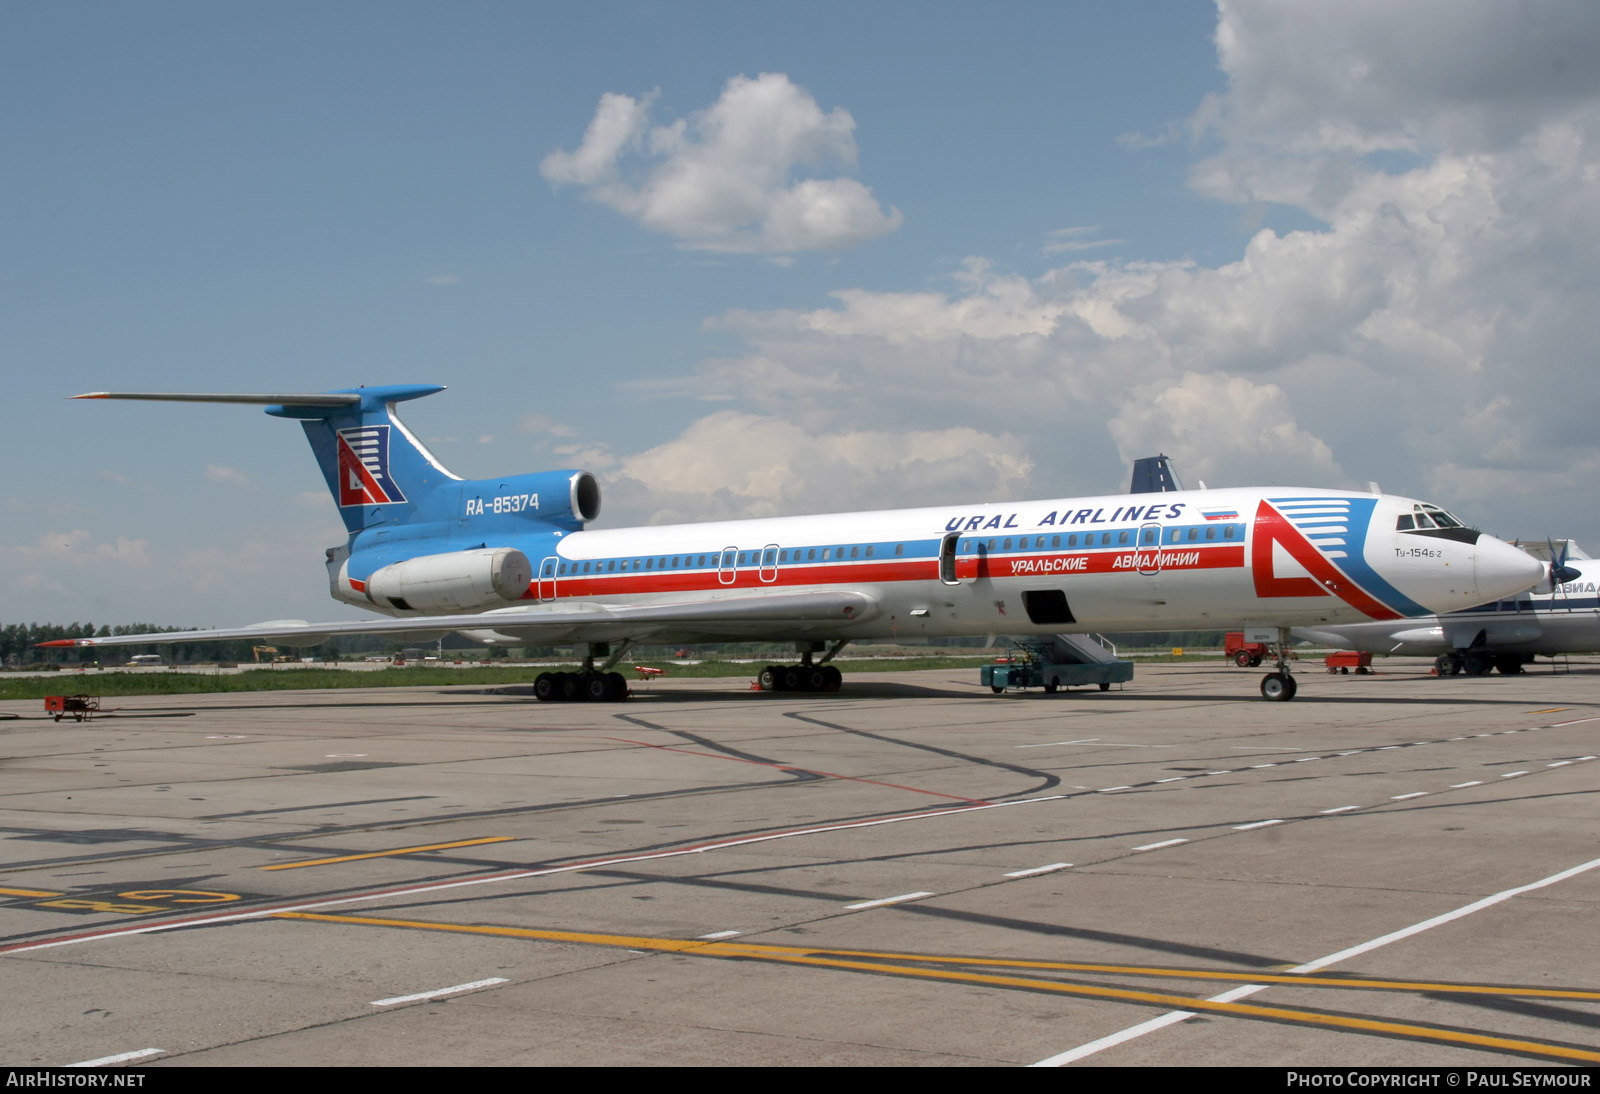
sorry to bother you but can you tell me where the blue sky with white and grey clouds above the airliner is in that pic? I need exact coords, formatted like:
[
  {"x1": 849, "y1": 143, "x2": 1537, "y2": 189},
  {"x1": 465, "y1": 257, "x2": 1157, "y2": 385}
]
[{"x1": 0, "y1": 2, "x2": 1600, "y2": 625}]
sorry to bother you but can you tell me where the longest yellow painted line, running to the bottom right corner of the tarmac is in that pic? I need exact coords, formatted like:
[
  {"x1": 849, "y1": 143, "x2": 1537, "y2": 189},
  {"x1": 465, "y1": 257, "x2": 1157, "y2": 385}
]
[{"x1": 277, "y1": 912, "x2": 1600, "y2": 1064}]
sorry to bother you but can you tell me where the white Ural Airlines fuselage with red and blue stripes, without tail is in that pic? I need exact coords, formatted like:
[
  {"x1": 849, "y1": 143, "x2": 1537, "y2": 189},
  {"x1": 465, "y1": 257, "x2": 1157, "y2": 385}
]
[{"x1": 444, "y1": 488, "x2": 1544, "y2": 640}]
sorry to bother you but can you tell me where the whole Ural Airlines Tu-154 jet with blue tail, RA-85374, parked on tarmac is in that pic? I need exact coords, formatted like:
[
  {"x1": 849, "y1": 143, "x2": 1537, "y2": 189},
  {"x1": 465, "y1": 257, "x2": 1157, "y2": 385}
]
[{"x1": 46, "y1": 385, "x2": 1547, "y2": 701}]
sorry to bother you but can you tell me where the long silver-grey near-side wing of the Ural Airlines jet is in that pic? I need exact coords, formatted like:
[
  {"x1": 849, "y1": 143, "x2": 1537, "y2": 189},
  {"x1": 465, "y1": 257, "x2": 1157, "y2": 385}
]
[{"x1": 40, "y1": 590, "x2": 878, "y2": 649}]
